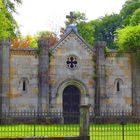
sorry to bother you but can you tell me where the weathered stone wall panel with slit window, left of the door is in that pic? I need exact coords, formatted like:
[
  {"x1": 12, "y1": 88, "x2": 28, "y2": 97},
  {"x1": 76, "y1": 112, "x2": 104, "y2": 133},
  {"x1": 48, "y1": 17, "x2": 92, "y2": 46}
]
[{"x1": 9, "y1": 50, "x2": 38, "y2": 110}]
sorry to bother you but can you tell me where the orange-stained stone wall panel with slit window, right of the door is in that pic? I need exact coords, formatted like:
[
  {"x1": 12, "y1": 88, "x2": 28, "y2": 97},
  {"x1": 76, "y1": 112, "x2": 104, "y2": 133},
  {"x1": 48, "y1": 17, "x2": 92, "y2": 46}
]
[{"x1": 101, "y1": 53, "x2": 132, "y2": 111}]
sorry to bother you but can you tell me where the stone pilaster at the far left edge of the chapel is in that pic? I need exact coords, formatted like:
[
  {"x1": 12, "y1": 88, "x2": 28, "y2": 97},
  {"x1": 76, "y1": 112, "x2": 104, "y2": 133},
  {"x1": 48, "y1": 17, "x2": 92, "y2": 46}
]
[{"x1": 0, "y1": 40, "x2": 10, "y2": 111}]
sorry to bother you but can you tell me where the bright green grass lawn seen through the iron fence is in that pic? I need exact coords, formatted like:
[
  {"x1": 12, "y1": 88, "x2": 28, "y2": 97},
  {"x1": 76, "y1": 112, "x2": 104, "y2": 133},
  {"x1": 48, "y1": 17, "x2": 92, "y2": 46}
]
[{"x1": 0, "y1": 124, "x2": 140, "y2": 140}]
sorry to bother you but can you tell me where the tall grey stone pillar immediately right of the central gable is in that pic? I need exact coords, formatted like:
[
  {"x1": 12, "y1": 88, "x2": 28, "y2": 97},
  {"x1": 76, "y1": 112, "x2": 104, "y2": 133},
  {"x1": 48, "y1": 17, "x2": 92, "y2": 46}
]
[{"x1": 95, "y1": 41, "x2": 106, "y2": 114}]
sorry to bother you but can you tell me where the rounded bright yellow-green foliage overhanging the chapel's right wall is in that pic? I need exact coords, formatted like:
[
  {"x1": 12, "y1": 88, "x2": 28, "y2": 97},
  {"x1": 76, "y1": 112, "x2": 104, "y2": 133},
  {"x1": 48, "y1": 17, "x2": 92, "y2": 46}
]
[{"x1": 116, "y1": 25, "x2": 140, "y2": 52}]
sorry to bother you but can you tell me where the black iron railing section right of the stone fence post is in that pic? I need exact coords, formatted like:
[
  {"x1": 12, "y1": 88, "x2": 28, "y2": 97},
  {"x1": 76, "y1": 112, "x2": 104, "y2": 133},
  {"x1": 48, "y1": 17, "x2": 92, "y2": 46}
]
[{"x1": 90, "y1": 111, "x2": 140, "y2": 140}]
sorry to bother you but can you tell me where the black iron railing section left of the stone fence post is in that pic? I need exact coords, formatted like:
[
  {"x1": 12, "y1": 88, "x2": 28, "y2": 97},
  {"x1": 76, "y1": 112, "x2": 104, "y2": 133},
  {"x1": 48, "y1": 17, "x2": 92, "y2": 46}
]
[{"x1": 0, "y1": 111, "x2": 80, "y2": 139}]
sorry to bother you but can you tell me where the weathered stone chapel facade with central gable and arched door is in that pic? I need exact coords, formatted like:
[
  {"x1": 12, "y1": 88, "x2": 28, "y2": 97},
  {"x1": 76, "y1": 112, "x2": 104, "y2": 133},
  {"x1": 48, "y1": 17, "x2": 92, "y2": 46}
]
[{"x1": 0, "y1": 15, "x2": 140, "y2": 116}]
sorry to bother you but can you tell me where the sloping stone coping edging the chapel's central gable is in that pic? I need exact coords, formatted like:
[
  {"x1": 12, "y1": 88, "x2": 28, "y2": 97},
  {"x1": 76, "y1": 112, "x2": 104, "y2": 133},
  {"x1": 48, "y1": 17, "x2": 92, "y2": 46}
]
[{"x1": 49, "y1": 29, "x2": 93, "y2": 54}]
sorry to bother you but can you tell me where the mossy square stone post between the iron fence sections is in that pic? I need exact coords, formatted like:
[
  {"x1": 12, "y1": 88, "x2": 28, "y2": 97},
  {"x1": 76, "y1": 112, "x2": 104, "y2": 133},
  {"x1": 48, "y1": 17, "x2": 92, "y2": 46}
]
[{"x1": 80, "y1": 105, "x2": 90, "y2": 140}]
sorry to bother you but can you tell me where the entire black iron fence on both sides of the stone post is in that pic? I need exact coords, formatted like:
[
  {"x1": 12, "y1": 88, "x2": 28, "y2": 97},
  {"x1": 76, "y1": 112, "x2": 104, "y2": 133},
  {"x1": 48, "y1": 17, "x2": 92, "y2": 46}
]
[{"x1": 0, "y1": 111, "x2": 140, "y2": 140}]
